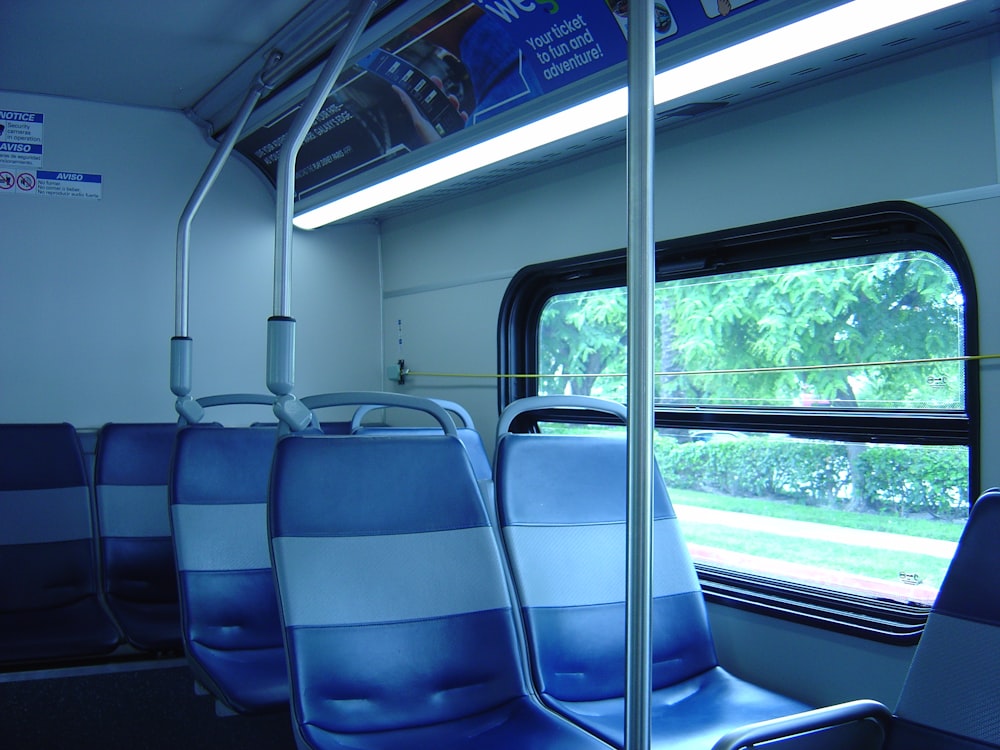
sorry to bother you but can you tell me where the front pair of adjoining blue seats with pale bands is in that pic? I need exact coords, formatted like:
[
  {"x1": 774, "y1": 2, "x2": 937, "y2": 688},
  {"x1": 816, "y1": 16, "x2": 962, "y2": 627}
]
[{"x1": 268, "y1": 394, "x2": 806, "y2": 750}]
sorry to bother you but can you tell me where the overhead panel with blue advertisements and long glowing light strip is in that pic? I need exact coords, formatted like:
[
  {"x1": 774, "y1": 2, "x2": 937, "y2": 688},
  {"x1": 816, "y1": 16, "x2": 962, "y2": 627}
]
[{"x1": 199, "y1": 0, "x2": 997, "y2": 228}]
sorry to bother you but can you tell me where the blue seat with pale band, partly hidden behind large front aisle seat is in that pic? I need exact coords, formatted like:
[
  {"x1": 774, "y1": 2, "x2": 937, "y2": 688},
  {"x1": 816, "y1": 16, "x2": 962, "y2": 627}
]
[{"x1": 169, "y1": 425, "x2": 288, "y2": 713}]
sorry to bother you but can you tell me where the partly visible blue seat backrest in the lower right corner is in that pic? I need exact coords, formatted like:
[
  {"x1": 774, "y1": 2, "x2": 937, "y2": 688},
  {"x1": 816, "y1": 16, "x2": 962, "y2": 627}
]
[{"x1": 890, "y1": 490, "x2": 1000, "y2": 750}]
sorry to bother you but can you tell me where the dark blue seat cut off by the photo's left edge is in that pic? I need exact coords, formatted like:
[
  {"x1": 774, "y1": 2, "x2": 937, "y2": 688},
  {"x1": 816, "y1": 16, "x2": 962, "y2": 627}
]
[{"x1": 0, "y1": 424, "x2": 121, "y2": 662}]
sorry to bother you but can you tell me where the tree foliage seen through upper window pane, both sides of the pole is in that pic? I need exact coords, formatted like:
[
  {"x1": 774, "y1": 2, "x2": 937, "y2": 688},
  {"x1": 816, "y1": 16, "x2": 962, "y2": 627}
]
[{"x1": 539, "y1": 252, "x2": 964, "y2": 408}]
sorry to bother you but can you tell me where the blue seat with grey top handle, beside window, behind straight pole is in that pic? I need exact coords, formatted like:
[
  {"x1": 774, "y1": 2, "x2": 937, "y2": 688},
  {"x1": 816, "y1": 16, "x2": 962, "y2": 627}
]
[{"x1": 495, "y1": 397, "x2": 806, "y2": 750}]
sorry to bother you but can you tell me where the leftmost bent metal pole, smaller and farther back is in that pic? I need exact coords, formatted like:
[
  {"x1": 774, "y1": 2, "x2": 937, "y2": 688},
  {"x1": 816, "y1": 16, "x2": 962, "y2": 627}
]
[{"x1": 170, "y1": 53, "x2": 281, "y2": 422}]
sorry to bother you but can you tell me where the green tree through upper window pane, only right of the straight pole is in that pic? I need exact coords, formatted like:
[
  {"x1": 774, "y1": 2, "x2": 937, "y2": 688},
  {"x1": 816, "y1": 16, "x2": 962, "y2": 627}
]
[{"x1": 660, "y1": 253, "x2": 963, "y2": 408}]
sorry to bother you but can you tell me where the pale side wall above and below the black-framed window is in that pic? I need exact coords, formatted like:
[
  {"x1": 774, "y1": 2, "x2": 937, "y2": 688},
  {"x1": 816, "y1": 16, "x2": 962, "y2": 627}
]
[{"x1": 382, "y1": 32, "x2": 1000, "y2": 706}]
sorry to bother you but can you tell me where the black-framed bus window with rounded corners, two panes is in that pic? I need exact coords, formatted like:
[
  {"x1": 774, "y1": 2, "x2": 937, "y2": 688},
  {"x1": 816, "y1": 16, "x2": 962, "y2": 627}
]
[{"x1": 501, "y1": 204, "x2": 977, "y2": 637}]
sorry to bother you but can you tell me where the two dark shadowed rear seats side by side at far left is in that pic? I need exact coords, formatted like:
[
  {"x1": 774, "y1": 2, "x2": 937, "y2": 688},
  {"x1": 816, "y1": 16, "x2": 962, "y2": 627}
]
[{"x1": 0, "y1": 423, "x2": 180, "y2": 664}]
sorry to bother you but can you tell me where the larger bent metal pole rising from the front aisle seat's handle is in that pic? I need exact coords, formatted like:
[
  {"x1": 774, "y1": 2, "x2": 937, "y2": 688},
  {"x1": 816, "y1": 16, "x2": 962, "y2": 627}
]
[{"x1": 267, "y1": 0, "x2": 378, "y2": 432}]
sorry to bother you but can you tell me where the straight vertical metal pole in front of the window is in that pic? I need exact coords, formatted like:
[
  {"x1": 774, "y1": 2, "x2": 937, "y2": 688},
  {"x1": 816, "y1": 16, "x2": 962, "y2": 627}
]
[{"x1": 625, "y1": 0, "x2": 655, "y2": 750}]
